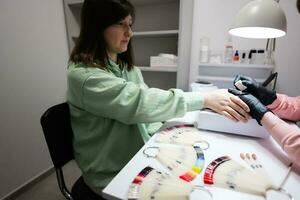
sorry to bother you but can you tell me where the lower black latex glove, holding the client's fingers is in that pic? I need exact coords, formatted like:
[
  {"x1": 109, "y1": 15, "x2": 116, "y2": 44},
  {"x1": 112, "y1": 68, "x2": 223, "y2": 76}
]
[{"x1": 228, "y1": 88, "x2": 269, "y2": 125}]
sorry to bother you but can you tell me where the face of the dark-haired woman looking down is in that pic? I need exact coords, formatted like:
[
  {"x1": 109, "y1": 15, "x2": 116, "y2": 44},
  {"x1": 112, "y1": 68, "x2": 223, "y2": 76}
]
[{"x1": 104, "y1": 15, "x2": 133, "y2": 56}]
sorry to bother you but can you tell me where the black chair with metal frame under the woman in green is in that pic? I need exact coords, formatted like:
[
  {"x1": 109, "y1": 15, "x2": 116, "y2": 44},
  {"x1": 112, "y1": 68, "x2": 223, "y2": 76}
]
[{"x1": 41, "y1": 103, "x2": 103, "y2": 200}]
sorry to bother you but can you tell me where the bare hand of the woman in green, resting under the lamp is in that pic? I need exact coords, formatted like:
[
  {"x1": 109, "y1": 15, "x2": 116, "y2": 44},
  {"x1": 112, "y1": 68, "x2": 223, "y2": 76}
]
[{"x1": 204, "y1": 89, "x2": 250, "y2": 122}]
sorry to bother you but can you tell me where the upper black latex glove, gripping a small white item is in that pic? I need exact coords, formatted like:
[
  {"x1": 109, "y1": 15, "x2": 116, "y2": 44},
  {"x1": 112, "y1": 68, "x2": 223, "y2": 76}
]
[{"x1": 233, "y1": 75, "x2": 277, "y2": 106}]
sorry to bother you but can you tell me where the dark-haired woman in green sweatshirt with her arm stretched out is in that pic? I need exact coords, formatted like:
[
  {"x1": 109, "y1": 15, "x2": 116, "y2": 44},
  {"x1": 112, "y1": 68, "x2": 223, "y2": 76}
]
[{"x1": 67, "y1": 0, "x2": 249, "y2": 194}]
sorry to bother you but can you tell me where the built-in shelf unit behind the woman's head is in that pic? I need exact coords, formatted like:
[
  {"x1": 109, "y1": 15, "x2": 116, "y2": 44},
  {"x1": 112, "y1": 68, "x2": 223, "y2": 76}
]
[{"x1": 64, "y1": 0, "x2": 182, "y2": 89}]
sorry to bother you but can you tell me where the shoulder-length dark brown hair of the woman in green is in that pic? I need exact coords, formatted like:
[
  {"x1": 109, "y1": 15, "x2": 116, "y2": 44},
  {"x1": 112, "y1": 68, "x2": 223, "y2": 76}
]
[{"x1": 70, "y1": 0, "x2": 135, "y2": 70}]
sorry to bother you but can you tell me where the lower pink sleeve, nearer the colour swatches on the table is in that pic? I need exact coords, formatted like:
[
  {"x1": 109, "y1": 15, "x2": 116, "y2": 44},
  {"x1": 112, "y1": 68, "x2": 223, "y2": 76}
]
[{"x1": 261, "y1": 112, "x2": 300, "y2": 166}]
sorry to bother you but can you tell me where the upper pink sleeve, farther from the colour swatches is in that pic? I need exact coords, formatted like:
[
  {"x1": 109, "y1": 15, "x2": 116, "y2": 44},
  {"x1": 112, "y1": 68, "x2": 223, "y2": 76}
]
[{"x1": 268, "y1": 94, "x2": 300, "y2": 121}]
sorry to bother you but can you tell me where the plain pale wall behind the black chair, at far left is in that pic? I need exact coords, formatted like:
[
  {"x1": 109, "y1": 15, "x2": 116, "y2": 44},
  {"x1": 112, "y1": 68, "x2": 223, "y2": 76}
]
[{"x1": 0, "y1": 0, "x2": 68, "y2": 199}]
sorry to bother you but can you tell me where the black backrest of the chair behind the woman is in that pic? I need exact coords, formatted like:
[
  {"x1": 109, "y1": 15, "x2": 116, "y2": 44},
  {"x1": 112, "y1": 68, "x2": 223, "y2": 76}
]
[{"x1": 41, "y1": 102, "x2": 74, "y2": 168}]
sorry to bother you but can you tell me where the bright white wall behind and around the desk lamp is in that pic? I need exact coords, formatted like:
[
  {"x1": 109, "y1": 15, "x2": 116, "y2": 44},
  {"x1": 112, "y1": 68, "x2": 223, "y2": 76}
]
[{"x1": 190, "y1": 0, "x2": 300, "y2": 95}]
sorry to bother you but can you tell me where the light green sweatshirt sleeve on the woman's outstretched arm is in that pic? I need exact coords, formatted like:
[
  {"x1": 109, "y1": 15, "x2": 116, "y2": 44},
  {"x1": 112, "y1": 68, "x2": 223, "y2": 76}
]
[{"x1": 82, "y1": 73, "x2": 187, "y2": 124}]
